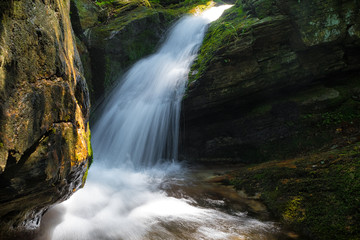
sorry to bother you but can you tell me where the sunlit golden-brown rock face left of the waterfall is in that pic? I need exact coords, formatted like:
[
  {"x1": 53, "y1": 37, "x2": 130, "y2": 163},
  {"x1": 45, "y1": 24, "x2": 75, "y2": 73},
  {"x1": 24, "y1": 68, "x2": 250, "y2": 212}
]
[{"x1": 0, "y1": 0, "x2": 90, "y2": 234}]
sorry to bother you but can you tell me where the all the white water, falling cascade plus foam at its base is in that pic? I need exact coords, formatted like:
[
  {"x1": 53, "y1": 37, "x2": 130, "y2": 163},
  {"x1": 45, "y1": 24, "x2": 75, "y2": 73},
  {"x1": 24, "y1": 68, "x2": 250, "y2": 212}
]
[{"x1": 39, "y1": 6, "x2": 280, "y2": 240}]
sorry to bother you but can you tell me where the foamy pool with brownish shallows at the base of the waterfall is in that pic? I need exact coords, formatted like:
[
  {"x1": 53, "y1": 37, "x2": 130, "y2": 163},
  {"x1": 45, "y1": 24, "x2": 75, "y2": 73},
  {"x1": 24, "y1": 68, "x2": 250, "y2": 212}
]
[{"x1": 35, "y1": 163, "x2": 300, "y2": 240}]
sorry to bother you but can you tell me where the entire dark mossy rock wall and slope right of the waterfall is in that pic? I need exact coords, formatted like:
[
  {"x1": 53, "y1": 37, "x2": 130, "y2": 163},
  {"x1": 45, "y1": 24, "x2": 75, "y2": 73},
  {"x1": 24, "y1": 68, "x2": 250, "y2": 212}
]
[{"x1": 181, "y1": 0, "x2": 360, "y2": 240}]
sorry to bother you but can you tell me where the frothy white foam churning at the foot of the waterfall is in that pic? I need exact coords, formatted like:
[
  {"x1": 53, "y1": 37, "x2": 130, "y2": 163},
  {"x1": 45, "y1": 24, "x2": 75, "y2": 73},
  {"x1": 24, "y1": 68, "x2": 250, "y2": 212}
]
[{"x1": 39, "y1": 163, "x2": 274, "y2": 240}]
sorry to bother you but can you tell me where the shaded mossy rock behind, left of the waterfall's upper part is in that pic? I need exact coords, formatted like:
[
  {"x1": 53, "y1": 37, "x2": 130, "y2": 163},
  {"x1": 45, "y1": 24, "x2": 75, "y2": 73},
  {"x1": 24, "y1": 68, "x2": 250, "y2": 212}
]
[{"x1": 87, "y1": 7, "x2": 176, "y2": 102}]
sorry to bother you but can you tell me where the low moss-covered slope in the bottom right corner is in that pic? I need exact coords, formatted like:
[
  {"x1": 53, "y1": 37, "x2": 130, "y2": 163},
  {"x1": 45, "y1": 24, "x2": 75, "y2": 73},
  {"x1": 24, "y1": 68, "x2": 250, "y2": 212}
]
[{"x1": 229, "y1": 142, "x2": 360, "y2": 240}]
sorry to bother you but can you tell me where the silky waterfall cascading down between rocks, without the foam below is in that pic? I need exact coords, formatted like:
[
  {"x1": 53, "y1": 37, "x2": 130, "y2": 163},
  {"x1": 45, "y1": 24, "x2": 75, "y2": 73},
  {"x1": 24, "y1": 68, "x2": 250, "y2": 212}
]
[{"x1": 92, "y1": 5, "x2": 229, "y2": 168}]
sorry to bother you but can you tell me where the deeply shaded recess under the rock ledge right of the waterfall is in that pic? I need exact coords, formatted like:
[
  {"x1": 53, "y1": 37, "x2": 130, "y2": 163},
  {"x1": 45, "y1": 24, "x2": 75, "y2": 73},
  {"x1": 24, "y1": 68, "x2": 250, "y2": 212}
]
[{"x1": 180, "y1": 71, "x2": 360, "y2": 163}]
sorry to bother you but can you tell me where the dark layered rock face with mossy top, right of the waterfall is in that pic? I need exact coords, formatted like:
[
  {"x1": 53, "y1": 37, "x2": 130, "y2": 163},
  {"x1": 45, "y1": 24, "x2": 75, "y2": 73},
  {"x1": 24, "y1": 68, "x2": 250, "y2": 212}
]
[{"x1": 182, "y1": 0, "x2": 360, "y2": 162}]
